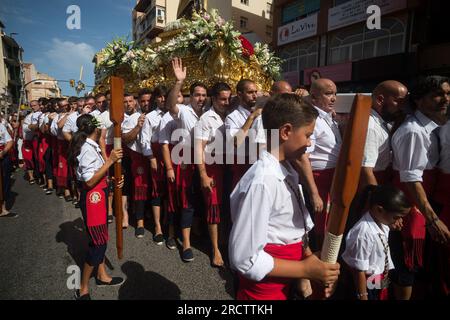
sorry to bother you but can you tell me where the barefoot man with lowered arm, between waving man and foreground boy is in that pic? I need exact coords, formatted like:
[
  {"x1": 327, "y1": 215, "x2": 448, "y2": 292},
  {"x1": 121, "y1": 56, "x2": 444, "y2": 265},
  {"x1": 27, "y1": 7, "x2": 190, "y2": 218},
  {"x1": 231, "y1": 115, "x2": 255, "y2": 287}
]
[{"x1": 195, "y1": 82, "x2": 231, "y2": 267}]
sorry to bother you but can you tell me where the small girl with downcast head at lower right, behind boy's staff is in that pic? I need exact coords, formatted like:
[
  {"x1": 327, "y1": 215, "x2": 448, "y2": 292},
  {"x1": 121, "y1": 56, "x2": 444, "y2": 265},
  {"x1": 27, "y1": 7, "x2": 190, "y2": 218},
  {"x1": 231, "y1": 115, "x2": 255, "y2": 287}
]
[{"x1": 342, "y1": 185, "x2": 411, "y2": 300}]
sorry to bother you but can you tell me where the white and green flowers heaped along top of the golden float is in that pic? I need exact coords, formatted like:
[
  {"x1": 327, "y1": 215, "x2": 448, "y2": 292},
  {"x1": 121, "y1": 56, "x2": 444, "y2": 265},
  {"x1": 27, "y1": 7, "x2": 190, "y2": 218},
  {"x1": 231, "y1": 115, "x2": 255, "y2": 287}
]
[{"x1": 97, "y1": 9, "x2": 282, "y2": 85}]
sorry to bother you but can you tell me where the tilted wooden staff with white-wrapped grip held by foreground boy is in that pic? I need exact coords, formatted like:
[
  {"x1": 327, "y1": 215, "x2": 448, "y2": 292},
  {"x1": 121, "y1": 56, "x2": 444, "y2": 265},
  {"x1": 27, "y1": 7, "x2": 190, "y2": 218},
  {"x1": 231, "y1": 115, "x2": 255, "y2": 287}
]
[{"x1": 321, "y1": 94, "x2": 372, "y2": 263}]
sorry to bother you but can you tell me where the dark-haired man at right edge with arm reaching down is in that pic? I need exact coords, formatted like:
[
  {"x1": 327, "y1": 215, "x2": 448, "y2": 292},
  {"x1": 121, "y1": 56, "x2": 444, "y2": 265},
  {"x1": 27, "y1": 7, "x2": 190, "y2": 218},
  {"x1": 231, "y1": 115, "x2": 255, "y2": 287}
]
[{"x1": 390, "y1": 76, "x2": 450, "y2": 300}]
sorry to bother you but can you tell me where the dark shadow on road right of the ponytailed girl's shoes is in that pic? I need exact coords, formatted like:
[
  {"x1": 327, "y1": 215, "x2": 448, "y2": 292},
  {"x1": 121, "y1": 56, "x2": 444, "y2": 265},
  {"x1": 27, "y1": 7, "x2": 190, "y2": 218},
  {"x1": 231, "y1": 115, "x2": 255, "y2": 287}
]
[{"x1": 119, "y1": 261, "x2": 181, "y2": 300}]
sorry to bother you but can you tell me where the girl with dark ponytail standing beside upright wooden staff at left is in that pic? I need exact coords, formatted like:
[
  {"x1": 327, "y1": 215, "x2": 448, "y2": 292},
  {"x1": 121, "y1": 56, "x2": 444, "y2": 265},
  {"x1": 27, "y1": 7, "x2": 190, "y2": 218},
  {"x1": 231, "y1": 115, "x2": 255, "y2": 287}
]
[{"x1": 68, "y1": 114, "x2": 123, "y2": 300}]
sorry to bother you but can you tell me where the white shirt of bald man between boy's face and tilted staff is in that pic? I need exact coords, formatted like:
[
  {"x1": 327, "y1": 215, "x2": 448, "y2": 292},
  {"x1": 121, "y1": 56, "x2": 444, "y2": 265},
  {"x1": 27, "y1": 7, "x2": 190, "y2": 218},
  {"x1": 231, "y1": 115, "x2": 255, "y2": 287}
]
[{"x1": 307, "y1": 107, "x2": 342, "y2": 170}]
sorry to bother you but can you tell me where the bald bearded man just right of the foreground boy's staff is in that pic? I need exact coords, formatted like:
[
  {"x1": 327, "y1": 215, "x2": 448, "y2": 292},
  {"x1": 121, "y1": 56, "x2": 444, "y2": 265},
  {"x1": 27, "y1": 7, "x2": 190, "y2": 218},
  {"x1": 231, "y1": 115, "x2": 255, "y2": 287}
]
[{"x1": 360, "y1": 80, "x2": 408, "y2": 190}]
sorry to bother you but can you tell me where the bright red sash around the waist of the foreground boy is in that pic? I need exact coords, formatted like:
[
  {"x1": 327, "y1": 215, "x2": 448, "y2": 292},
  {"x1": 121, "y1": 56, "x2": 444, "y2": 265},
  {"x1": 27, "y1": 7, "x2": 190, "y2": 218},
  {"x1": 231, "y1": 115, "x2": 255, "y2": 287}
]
[{"x1": 236, "y1": 242, "x2": 303, "y2": 300}]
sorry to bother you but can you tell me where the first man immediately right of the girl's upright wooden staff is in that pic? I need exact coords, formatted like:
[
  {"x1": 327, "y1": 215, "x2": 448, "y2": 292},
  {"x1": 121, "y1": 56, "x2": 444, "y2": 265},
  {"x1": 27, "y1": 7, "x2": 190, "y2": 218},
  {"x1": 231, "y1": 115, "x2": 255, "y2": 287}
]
[{"x1": 122, "y1": 94, "x2": 149, "y2": 238}]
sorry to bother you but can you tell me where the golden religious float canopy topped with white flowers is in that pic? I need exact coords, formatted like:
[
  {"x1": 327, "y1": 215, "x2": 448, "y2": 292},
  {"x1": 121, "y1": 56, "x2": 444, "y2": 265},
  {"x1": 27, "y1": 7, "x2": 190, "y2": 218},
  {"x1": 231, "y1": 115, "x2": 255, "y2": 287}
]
[{"x1": 95, "y1": 10, "x2": 282, "y2": 94}]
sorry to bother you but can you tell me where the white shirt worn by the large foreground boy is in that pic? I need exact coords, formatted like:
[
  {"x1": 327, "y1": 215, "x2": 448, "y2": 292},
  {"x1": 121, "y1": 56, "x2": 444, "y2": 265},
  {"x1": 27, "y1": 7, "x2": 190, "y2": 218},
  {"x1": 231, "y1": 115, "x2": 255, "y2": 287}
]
[{"x1": 228, "y1": 151, "x2": 313, "y2": 281}]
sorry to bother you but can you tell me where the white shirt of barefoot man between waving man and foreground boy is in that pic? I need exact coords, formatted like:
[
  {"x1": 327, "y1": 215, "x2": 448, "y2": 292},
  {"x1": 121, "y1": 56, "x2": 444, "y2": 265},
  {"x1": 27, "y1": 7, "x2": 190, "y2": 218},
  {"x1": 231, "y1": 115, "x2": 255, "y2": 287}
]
[{"x1": 194, "y1": 107, "x2": 225, "y2": 155}]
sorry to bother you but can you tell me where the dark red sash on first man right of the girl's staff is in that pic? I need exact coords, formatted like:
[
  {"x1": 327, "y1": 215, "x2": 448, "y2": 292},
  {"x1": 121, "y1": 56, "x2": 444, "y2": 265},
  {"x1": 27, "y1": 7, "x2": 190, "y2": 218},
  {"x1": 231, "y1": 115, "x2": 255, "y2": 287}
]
[{"x1": 128, "y1": 149, "x2": 149, "y2": 201}]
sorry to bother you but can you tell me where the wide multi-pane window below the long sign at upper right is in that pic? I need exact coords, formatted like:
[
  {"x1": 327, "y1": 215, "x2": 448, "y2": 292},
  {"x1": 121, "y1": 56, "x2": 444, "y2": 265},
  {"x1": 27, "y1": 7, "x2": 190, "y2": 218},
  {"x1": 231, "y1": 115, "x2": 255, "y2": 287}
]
[{"x1": 328, "y1": 16, "x2": 406, "y2": 64}]
